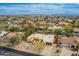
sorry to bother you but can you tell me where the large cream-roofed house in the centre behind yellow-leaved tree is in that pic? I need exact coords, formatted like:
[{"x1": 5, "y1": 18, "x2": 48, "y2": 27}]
[{"x1": 27, "y1": 34, "x2": 54, "y2": 44}]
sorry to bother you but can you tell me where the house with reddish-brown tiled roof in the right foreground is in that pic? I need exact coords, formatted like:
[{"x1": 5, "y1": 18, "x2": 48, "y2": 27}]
[{"x1": 59, "y1": 37, "x2": 79, "y2": 48}]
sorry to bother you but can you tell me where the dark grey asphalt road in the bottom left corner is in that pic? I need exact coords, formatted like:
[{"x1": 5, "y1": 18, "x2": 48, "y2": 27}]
[{"x1": 0, "y1": 46, "x2": 39, "y2": 56}]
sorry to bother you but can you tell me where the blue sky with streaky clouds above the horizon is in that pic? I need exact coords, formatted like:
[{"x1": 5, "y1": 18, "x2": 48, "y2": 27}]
[{"x1": 0, "y1": 3, "x2": 79, "y2": 16}]
